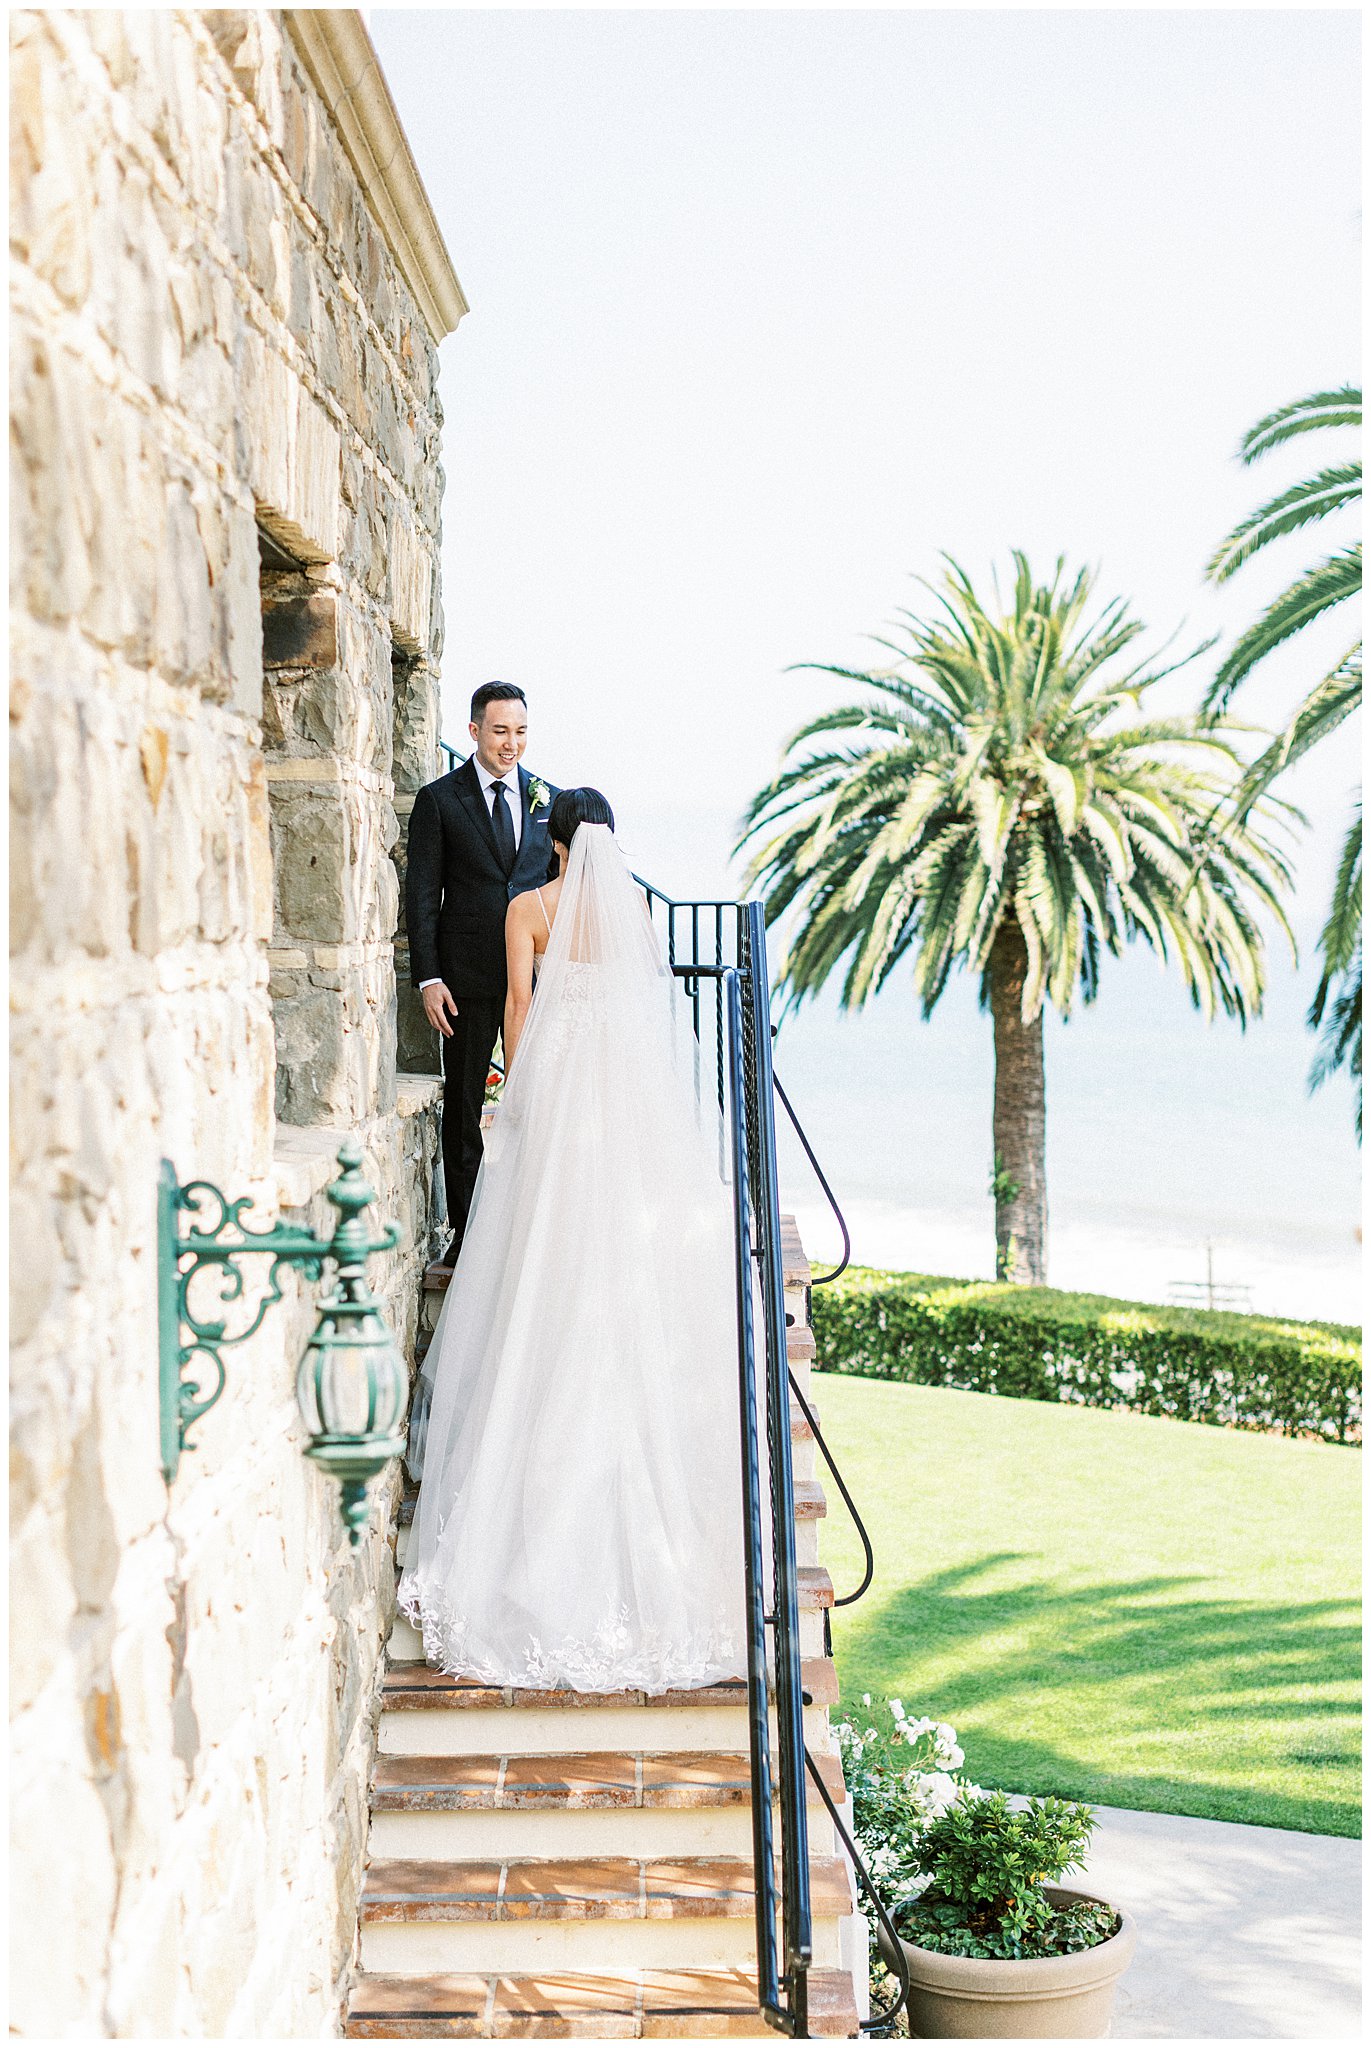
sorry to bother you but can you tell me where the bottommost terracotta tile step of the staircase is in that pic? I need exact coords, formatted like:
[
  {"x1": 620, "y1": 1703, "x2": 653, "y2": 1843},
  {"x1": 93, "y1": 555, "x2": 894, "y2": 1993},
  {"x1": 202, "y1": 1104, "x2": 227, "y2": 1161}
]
[{"x1": 344, "y1": 1970, "x2": 857, "y2": 2040}]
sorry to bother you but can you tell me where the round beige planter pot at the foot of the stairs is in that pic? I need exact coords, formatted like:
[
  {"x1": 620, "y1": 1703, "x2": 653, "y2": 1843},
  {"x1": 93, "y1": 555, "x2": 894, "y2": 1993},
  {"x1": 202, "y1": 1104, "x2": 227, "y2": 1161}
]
[{"x1": 881, "y1": 1884, "x2": 1137, "y2": 2042}]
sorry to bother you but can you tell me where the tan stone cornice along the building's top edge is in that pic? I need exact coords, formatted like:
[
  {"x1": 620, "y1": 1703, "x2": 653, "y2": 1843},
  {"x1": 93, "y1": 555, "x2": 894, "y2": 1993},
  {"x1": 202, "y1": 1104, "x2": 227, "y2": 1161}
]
[{"x1": 285, "y1": 6, "x2": 467, "y2": 342}]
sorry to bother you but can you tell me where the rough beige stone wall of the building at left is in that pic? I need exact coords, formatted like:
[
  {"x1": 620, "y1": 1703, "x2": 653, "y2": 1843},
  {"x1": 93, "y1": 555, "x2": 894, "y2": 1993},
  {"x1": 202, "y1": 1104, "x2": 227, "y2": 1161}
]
[{"x1": 10, "y1": 10, "x2": 443, "y2": 2038}]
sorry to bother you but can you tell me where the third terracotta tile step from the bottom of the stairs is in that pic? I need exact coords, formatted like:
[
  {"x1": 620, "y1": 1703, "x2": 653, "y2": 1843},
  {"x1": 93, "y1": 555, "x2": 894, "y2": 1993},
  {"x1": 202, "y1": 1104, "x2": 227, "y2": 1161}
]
[{"x1": 371, "y1": 1751, "x2": 842, "y2": 1812}]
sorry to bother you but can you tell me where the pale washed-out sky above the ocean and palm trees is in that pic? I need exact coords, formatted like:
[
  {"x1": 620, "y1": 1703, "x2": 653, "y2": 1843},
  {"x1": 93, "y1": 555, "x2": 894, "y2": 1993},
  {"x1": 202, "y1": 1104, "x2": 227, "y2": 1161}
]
[{"x1": 369, "y1": 8, "x2": 1359, "y2": 1310}]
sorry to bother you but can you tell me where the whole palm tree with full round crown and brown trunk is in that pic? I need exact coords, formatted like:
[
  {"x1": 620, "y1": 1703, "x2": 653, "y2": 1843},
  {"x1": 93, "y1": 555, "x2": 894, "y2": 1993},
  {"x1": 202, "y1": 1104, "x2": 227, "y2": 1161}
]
[{"x1": 738, "y1": 553, "x2": 1289, "y2": 1284}]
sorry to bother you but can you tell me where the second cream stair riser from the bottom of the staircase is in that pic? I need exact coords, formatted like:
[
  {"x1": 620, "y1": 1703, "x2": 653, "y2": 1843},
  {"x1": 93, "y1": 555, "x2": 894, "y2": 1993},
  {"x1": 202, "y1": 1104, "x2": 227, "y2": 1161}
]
[{"x1": 369, "y1": 1800, "x2": 836, "y2": 1862}]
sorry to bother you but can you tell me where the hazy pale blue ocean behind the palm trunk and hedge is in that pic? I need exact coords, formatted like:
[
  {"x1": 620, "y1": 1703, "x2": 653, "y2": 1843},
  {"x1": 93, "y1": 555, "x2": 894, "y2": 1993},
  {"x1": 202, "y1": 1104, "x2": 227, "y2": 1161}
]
[{"x1": 619, "y1": 801, "x2": 1361, "y2": 1321}]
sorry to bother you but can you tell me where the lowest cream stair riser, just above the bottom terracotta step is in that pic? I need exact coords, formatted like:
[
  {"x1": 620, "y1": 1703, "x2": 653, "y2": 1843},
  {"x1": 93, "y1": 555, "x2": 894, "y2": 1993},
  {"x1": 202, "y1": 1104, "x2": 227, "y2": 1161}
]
[{"x1": 361, "y1": 1917, "x2": 840, "y2": 1976}]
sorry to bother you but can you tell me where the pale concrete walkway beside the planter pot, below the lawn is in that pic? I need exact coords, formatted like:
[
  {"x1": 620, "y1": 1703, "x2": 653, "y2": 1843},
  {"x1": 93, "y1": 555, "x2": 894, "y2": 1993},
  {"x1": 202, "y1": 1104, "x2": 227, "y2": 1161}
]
[{"x1": 1064, "y1": 1806, "x2": 1361, "y2": 2040}]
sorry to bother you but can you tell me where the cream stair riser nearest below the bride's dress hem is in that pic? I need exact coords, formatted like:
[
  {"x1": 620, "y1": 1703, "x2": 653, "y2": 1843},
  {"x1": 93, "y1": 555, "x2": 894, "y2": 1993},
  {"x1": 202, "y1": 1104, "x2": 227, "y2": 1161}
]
[{"x1": 377, "y1": 1706, "x2": 832, "y2": 1757}]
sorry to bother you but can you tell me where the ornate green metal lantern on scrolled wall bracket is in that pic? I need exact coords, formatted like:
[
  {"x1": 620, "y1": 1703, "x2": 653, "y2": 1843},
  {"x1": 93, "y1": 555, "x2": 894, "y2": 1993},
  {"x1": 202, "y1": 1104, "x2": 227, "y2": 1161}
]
[{"x1": 158, "y1": 1139, "x2": 410, "y2": 1542}]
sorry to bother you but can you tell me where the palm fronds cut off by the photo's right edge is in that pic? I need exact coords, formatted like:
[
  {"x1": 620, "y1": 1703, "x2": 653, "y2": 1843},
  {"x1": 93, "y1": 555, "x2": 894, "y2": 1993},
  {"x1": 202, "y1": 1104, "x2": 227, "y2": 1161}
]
[{"x1": 1205, "y1": 385, "x2": 1361, "y2": 1135}]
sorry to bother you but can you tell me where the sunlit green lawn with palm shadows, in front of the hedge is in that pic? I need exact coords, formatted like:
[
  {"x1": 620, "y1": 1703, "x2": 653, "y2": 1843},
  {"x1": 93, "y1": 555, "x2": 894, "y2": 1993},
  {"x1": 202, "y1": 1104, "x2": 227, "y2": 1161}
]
[{"x1": 814, "y1": 1372, "x2": 1361, "y2": 1835}]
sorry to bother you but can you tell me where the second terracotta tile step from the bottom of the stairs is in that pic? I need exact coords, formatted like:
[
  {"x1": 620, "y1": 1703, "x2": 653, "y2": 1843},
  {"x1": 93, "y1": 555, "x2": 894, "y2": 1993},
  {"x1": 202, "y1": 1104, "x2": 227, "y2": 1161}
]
[{"x1": 361, "y1": 1855, "x2": 850, "y2": 1925}]
